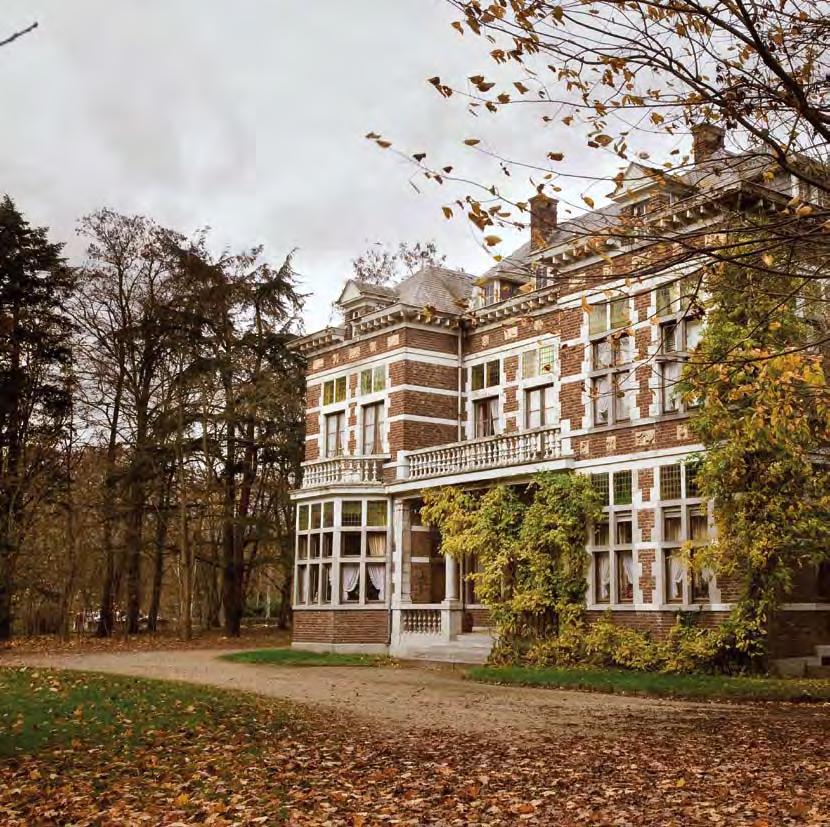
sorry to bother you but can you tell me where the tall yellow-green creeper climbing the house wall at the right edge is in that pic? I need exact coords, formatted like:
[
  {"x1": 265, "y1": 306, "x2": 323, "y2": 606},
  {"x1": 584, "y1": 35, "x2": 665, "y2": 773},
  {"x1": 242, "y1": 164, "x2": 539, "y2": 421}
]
[{"x1": 684, "y1": 252, "x2": 830, "y2": 628}]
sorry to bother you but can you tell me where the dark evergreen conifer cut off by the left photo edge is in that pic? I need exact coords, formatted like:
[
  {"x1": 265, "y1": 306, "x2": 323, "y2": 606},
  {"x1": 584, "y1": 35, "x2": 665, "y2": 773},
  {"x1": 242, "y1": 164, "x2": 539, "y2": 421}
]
[{"x1": 0, "y1": 196, "x2": 74, "y2": 640}]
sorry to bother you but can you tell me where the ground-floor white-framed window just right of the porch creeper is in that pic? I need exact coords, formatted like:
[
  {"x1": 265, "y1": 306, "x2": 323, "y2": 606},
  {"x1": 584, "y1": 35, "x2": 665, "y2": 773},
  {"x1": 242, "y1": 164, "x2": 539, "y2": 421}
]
[{"x1": 588, "y1": 470, "x2": 635, "y2": 604}]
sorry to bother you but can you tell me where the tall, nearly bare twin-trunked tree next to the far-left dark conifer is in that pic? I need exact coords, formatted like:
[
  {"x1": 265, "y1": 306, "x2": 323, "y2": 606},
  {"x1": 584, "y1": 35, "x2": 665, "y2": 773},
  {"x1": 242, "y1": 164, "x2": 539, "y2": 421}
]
[{"x1": 74, "y1": 209, "x2": 184, "y2": 635}]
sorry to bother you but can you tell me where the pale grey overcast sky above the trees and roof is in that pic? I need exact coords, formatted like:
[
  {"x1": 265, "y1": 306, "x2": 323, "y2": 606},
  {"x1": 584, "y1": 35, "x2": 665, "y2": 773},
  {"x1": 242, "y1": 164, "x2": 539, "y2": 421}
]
[{"x1": 0, "y1": 0, "x2": 644, "y2": 330}]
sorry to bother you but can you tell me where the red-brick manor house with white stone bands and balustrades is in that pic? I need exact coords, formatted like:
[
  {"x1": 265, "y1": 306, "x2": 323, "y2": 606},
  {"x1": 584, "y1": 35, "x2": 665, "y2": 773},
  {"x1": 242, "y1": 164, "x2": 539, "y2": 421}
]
[{"x1": 293, "y1": 125, "x2": 830, "y2": 661}]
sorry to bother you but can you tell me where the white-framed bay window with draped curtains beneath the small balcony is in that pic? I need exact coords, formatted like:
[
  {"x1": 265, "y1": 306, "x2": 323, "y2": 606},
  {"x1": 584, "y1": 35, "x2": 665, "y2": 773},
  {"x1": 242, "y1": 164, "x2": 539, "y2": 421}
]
[{"x1": 294, "y1": 499, "x2": 389, "y2": 607}]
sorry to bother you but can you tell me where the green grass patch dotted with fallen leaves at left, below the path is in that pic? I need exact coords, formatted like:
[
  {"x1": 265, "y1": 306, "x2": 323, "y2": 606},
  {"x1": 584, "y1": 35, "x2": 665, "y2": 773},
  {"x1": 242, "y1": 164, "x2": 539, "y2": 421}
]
[{"x1": 0, "y1": 669, "x2": 282, "y2": 757}]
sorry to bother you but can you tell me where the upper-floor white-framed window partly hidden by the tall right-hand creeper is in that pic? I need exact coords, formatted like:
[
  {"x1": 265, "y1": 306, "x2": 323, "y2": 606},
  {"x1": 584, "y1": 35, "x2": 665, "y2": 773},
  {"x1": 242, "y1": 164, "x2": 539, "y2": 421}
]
[{"x1": 655, "y1": 277, "x2": 703, "y2": 413}]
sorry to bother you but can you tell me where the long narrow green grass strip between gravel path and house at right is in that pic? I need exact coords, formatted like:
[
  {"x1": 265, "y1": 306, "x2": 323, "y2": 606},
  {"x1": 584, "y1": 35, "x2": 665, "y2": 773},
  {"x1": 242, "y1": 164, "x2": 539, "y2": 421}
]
[{"x1": 467, "y1": 666, "x2": 830, "y2": 701}]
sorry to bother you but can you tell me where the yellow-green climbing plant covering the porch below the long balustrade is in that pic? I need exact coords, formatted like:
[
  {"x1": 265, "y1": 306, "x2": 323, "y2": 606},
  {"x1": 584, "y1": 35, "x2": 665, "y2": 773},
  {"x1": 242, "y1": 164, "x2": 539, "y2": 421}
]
[{"x1": 421, "y1": 473, "x2": 600, "y2": 661}]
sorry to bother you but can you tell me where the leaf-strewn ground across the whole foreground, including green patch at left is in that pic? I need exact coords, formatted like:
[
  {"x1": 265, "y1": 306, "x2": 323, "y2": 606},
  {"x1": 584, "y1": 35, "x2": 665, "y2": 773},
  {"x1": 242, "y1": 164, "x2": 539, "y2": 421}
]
[{"x1": 0, "y1": 669, "x2": 830, "y2": 827}]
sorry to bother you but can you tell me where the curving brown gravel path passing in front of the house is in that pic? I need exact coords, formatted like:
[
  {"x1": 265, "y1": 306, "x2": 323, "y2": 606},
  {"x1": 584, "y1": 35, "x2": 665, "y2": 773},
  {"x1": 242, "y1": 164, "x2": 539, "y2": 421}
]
[{"x1": 0, "y1": 650, "x2": 772, "y2": 740}]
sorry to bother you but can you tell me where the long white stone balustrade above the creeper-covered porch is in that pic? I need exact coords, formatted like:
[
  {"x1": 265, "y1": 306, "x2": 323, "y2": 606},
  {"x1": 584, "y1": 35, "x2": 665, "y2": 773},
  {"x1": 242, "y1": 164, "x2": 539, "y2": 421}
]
[{"x1": 407, "y1": 428, "x2": 565, "y2": 480}]
